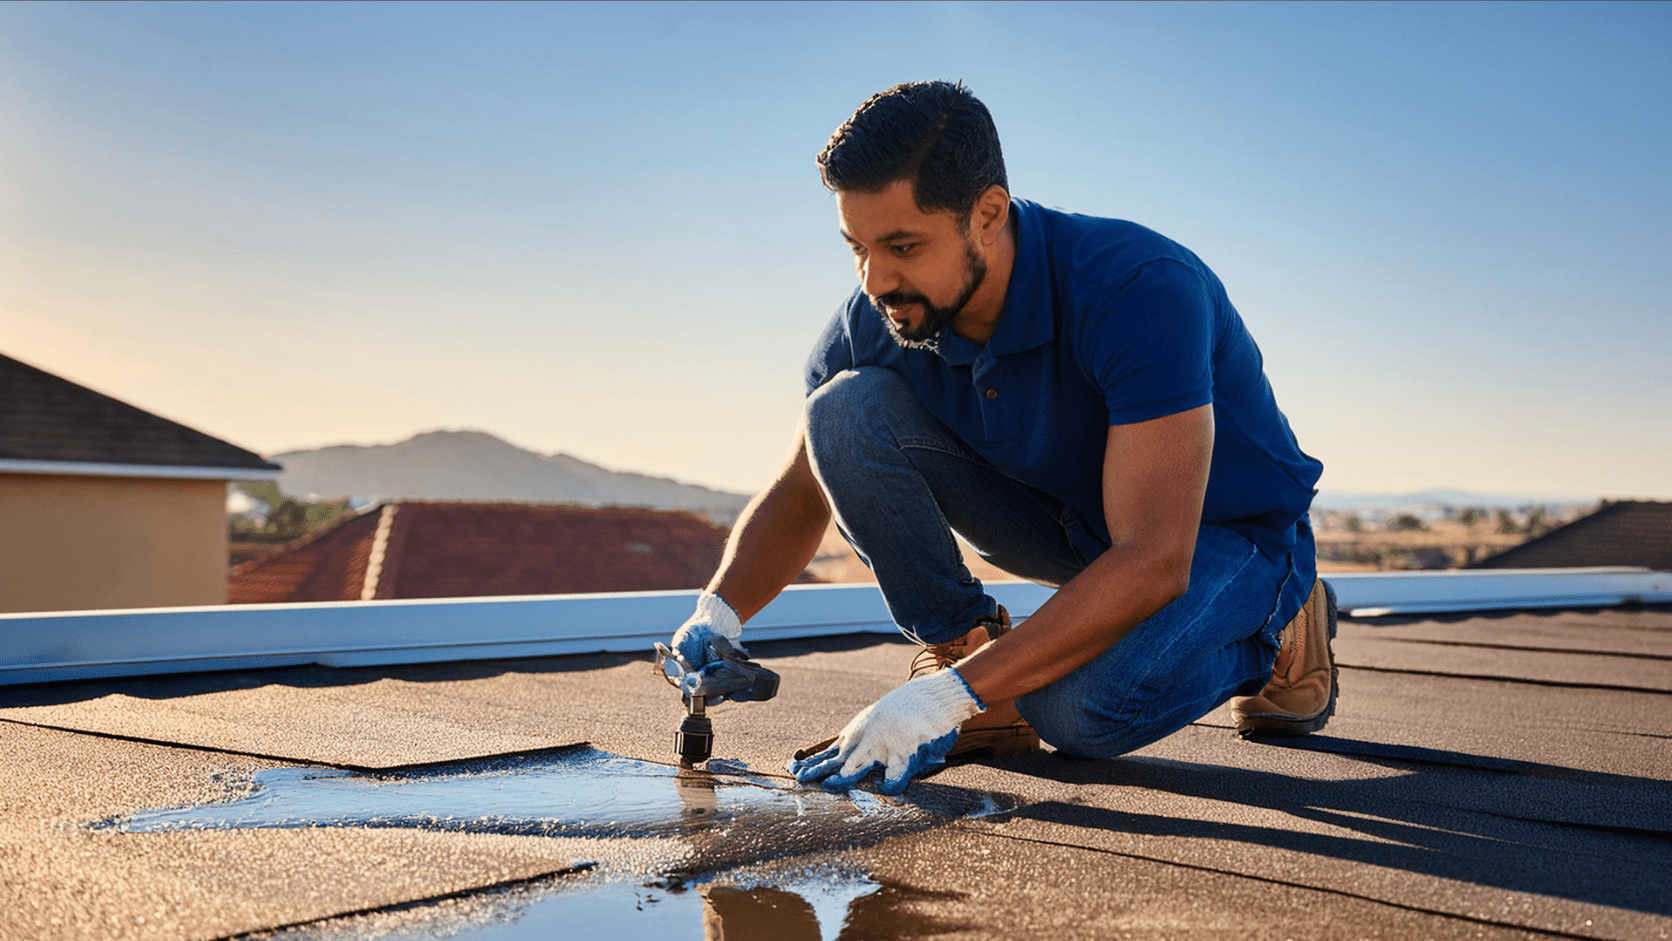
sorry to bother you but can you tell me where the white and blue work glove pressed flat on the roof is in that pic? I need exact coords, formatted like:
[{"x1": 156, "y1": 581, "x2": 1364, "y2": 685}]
[{"x1": 789, "y1": 667, "x2": 986, "y2": 794}]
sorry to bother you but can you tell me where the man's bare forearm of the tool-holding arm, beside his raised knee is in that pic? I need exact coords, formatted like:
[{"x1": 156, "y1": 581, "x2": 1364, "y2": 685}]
[{"x1": 709, "y1": 437, "x2": 831, "y2": 620}]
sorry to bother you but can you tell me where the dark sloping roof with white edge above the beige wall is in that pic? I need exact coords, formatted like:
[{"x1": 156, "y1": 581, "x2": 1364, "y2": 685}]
[{"x1": 0, "y1": 356, "x2": 283, "y2": 478}]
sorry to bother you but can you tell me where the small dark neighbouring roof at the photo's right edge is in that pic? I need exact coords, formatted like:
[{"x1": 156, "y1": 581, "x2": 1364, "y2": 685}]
[{"x1": 1473, "y1": 500, "x2": 1672, "y2": 572}]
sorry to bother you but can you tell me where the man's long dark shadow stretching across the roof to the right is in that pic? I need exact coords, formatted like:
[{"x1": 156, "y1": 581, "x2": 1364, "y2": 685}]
[{"x1": 1005, "y1": 737, "x2": 1672, "y2": 916}]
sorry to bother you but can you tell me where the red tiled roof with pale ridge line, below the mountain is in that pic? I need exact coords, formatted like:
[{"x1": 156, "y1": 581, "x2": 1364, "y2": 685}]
[{"x1": 229, "y1": 500, "x2": 745, "y2": 603}]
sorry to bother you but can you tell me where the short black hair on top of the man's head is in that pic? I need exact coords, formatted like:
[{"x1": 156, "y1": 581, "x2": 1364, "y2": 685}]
[{"x1": 818, "y1": 82, "x2": 1010, "y2": 226}]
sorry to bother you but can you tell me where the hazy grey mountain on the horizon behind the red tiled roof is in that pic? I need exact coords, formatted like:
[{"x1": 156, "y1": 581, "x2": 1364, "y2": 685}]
[{"x1": 269, "y1": 431, "x2": 749, "y2": 523}]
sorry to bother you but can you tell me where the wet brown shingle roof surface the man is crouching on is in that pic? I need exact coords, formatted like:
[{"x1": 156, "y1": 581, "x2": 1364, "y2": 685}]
[{"x1": 0, "y1": 608, "x2": 1672, "y2": 941}]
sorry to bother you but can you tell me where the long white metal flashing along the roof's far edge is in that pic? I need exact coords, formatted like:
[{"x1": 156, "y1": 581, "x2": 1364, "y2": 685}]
[{"x1": 0, "y1": 568, "x2": 1672, "y2": 685}]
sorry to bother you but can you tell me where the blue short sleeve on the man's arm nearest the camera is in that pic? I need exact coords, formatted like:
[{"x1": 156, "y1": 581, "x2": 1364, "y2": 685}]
[{"x1": 1082, "y1": 259, "x2": 1214, "y2": 425}]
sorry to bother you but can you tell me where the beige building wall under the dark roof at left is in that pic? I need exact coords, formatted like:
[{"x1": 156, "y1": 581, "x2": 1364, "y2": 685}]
[{"x1": 0, "y1": 473, "x2": 227, "y2": 612}]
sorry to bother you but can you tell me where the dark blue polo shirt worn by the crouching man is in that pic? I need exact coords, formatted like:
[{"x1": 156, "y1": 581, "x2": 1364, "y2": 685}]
[{"x1": 806, "y1": 199, "x2": 1323, "y2": 563}]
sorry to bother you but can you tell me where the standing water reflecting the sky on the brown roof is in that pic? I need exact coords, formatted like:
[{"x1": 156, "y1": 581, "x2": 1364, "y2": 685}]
[{"x1": 104, "y1": 747, "x2": 1015, "y2": 941}]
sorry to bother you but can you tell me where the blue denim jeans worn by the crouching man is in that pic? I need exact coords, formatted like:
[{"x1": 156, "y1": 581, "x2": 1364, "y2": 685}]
[{"x1": 804, "y1": 366, "x2": 1316, "y2": 757}]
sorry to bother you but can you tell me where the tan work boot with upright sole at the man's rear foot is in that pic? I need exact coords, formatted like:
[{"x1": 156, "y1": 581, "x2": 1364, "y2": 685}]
[{"x1": 1231, "y1": 578, "x2": 1336, "y2": 739}]
